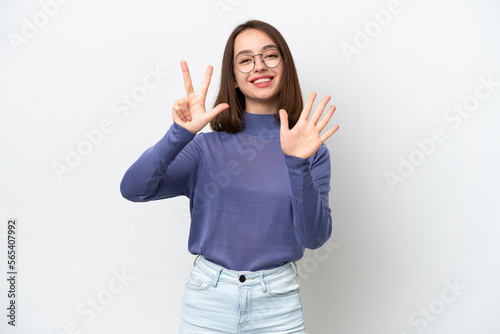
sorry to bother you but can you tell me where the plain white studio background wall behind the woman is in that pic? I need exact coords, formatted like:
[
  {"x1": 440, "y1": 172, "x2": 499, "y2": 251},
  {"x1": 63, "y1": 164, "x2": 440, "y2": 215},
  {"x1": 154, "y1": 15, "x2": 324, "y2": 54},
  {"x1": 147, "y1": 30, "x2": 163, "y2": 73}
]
[{"x1": 0, "y1": 0, "x2": 500, "y2": 334}]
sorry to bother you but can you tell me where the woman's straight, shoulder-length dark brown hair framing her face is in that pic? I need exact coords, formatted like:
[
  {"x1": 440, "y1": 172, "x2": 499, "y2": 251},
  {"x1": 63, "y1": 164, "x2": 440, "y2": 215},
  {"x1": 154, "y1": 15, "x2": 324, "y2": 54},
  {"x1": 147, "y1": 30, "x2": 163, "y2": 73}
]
[{"x1": 210, "y1": 20, "x2": 304, "y2": 133}]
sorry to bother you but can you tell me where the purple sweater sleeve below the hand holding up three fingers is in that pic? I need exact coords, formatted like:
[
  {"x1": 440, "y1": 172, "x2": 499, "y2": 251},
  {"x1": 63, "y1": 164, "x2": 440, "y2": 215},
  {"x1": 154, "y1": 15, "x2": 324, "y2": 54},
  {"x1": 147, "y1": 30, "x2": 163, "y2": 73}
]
[{"x1": 120, "y1": 122, "x2": 201, "y2": 202}]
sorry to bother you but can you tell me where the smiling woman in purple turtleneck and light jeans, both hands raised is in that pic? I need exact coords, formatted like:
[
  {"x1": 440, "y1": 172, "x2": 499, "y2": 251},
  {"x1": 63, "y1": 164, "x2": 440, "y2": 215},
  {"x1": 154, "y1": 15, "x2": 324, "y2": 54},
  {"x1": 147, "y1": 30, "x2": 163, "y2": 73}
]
[{"x1": 121, "y1": 20, "x2": 338, "y2": 333}]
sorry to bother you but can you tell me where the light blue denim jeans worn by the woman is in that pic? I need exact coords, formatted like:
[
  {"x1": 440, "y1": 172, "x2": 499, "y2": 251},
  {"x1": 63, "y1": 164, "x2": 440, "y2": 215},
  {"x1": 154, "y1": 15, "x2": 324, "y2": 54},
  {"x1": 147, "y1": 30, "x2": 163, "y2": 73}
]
[{"x1": 180, "y1": 256, "x2": 306, "y2": 334}]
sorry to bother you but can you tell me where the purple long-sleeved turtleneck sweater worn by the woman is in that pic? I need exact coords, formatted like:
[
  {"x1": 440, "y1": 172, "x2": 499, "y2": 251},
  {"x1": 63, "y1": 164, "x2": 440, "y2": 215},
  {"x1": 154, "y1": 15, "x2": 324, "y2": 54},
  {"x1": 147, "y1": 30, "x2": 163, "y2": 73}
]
[{"x1": 120, "y1": 113, "x2": 332, "y2": 271}]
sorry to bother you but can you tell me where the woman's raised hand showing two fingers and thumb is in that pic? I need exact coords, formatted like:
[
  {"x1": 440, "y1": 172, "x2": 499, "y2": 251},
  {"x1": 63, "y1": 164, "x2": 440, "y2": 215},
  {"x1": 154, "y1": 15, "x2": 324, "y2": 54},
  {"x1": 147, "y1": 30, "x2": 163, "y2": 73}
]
[{"x1": 172, "y1": 61, "x2": 229, "y2": 134}]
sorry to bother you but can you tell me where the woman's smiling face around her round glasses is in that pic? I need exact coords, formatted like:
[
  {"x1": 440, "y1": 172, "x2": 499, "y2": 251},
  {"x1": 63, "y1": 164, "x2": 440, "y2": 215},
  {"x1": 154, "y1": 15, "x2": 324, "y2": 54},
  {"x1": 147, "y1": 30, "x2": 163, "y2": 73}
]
[{"x1": 233, "y1": 29, "x2": 283, "y2": 104}]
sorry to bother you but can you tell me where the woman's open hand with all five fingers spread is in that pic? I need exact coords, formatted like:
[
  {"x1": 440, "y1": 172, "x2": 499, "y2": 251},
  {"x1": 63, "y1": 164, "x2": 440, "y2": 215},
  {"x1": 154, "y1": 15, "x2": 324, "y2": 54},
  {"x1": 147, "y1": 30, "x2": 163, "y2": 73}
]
[{"x1": 280, "y1": 93, "x2": 339, "y2": 159}]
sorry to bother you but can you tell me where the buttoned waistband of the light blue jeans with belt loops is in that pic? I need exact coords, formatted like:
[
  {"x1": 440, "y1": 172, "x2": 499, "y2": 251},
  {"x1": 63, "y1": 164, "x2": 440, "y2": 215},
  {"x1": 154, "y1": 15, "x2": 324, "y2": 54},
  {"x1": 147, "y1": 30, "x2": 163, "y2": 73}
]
[{"x1": 194, "y1": 254, "x2": 297, "y2": 292}]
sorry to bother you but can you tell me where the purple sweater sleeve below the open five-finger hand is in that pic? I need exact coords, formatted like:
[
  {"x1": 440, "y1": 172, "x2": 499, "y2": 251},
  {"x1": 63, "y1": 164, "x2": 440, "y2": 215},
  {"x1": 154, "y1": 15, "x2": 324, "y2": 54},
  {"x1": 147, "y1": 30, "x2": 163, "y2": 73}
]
[{"x1": 285, "y1": 144, "x2": 332, "y2": 249}]
